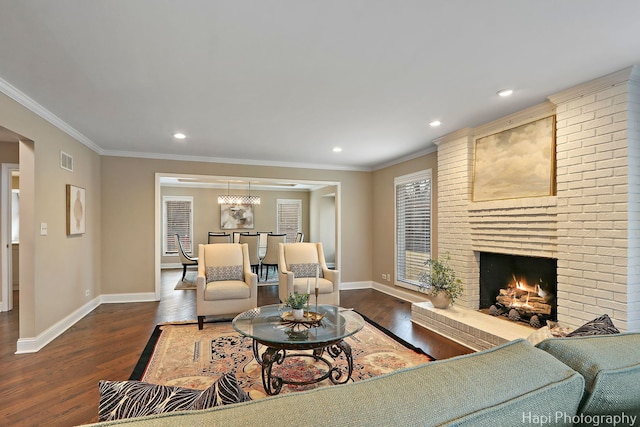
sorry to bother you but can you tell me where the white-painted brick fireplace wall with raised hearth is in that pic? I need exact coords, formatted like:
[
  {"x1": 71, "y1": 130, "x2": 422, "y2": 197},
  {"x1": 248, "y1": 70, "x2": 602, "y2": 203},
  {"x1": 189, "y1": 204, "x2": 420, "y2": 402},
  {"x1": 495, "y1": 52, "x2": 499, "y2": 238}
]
[{"x1": 412, "y1": 66, "x2": 640, "y2": 349}]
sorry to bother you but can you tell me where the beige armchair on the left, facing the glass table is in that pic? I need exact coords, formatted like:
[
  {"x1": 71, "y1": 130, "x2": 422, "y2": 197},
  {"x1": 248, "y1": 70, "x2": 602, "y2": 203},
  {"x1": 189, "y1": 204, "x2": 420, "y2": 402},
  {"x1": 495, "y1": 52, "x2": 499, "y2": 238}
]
[{"x1": 196, "y1": 243, "x2": 258, "y2": 329}]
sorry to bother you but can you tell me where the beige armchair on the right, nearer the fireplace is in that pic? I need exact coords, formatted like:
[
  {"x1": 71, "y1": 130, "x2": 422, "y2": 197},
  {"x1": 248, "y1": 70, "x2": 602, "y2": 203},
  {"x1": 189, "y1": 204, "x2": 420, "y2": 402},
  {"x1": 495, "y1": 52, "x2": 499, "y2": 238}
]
[{"x1": 278, "y1": 243, "x2": 340, "y2": 305}]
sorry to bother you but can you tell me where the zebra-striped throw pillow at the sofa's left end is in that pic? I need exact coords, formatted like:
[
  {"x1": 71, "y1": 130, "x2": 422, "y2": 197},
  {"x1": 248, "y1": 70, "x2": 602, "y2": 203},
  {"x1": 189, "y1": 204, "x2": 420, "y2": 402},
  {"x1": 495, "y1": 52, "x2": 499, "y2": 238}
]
[{"x1": 98, "y1": 373, "x2": 251, "y2": 421}]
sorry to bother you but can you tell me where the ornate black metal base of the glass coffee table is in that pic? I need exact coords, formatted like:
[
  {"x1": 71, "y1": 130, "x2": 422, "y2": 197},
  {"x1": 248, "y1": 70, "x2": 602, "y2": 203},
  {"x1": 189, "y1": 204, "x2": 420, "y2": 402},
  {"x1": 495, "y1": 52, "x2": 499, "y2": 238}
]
[{"x1": 253, "y1": 340, "x2": 353, "y2": 395}]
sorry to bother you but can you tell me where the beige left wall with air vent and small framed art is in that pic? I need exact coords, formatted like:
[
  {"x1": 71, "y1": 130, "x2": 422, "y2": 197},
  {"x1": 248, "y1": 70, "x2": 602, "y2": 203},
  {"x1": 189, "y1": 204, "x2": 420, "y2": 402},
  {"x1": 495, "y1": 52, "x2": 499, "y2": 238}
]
[{"x1": 0, "y1": 94, "x2": 102, "y2": 337}]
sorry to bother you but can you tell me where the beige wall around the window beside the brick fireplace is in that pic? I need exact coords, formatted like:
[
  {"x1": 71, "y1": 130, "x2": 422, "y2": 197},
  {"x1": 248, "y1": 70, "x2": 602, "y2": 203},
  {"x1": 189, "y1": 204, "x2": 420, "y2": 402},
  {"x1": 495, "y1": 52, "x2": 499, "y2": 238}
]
[{"x1": 372, "y1": 152, "x2": 438, "y2": 285}]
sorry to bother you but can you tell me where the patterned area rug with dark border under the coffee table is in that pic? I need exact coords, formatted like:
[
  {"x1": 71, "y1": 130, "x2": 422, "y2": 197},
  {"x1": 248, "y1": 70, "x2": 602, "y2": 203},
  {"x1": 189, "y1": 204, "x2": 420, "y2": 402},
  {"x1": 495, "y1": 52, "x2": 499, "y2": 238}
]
[{"x1": 131, "y1": 316, "x2": 433, "y2": 399}]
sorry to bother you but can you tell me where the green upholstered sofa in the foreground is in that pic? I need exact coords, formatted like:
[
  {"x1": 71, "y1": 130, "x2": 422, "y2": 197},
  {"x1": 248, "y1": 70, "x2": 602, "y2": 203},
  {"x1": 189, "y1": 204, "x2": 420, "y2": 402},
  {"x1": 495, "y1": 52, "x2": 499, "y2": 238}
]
[{"x1": 82, "y1": 333, "x2": 640, "y2": 427}]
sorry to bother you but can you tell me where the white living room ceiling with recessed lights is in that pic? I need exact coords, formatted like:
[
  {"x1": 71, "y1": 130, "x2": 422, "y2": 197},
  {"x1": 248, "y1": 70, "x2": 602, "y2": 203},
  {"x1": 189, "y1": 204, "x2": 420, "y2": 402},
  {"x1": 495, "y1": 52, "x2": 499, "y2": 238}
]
[{"x1": 0, "y1": 0, "x2": 640, "y2": 170}]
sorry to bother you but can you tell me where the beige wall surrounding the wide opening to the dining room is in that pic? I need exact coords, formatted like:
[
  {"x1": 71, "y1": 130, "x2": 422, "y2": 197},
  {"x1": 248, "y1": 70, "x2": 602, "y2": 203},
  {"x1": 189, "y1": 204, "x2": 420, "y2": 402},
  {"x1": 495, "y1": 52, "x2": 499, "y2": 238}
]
[{"x1": 101, "y1": 156, "x2": 372, "y2": 294}]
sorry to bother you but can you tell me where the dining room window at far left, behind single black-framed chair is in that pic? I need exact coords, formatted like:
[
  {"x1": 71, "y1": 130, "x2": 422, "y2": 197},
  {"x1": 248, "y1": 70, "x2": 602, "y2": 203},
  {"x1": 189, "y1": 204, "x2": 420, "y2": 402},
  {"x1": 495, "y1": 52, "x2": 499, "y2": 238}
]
[{"x1": 162, "y1": 196, "x2": 193, "y2": 255}]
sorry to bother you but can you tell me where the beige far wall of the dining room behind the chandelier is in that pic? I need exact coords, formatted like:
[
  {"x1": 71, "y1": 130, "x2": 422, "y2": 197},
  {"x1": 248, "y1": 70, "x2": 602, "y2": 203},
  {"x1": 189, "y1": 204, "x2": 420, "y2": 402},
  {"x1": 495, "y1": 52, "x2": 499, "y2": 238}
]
[{"x1": 160, "y1": 187, "x2": 309, "y2": 264}]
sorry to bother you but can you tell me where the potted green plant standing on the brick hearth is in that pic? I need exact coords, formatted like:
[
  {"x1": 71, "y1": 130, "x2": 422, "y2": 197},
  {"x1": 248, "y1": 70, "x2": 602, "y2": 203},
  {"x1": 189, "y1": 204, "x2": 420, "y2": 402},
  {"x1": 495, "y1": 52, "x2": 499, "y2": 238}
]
[{"x1": 418, "y1": 252, "x2": 463, "y2": 308}]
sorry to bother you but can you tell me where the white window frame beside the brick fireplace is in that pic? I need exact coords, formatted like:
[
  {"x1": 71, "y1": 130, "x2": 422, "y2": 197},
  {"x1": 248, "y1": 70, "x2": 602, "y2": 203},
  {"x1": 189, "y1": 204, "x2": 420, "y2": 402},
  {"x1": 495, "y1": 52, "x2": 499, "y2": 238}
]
[{"x1": 393, "y1": 169, "x2": 433, "y2": 290}]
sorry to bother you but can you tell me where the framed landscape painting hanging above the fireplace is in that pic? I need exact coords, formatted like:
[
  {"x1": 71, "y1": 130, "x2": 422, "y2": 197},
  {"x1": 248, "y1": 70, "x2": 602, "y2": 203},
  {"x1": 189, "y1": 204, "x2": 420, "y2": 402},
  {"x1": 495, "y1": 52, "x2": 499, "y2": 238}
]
[{"x1": 473, "y1": 116, "x2": 556, "y2": 202}]
